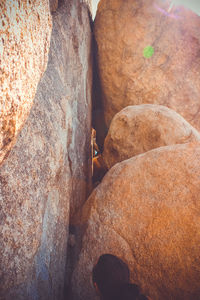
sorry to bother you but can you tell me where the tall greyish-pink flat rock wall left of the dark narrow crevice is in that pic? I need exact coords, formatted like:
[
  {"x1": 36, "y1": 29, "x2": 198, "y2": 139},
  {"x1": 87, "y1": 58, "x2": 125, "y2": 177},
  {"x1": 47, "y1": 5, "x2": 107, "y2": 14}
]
[{"x1": 0, "y1": 0, "x2": 92, "y2": 300}]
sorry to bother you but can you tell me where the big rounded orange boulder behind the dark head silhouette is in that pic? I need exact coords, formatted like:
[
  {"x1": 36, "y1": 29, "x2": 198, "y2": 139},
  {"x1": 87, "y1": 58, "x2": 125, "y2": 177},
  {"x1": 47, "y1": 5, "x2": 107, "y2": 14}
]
[{"x1": 73, "y1": 143, "x2": 200, "y2": 300}]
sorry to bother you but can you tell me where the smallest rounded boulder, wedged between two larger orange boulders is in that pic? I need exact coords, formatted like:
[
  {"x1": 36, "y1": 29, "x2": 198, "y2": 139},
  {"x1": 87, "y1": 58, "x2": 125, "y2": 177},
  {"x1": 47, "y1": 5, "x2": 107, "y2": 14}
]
[{"x1": 103, "y1": 104, "x2": 200, "y2": 169}]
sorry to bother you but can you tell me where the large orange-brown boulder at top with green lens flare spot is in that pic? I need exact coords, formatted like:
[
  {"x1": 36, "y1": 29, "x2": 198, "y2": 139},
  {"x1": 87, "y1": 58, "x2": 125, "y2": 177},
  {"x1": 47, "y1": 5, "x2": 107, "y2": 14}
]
[{"x1": 95, "y1": 0, "x2": 200, "y2": 129}]
